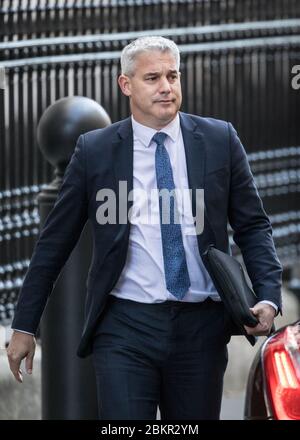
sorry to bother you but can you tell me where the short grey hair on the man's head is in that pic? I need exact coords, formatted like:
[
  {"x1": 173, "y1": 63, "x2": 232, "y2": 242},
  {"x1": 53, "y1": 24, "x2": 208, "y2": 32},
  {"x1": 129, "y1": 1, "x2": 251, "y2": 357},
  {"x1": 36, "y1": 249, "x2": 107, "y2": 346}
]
[{"x1": 121, "y1": 36, "x2": 180, "y2": 76}]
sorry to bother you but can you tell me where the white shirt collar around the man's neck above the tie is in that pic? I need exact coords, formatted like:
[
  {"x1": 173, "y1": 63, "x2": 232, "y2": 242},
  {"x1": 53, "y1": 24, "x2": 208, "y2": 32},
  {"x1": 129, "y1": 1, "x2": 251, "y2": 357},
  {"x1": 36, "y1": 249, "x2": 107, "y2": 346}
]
[{"x1": 131, "y1": 113, "x2": 180, "y2": 147}]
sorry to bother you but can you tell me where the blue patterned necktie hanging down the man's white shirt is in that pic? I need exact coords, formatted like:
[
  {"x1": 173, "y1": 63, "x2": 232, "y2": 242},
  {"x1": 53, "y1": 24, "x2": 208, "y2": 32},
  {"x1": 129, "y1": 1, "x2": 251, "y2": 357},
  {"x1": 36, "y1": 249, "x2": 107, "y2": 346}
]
[{"x1": 152, "y1": 132, "x2": 191, "y2": 299}]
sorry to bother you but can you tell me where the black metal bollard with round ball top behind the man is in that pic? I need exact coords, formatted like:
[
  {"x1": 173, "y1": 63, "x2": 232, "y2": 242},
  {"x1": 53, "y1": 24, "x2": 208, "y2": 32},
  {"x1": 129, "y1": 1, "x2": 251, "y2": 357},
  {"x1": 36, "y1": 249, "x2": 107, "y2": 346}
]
[{"x1": 38, "y1": 96, "x2": 111, "y2": 420}]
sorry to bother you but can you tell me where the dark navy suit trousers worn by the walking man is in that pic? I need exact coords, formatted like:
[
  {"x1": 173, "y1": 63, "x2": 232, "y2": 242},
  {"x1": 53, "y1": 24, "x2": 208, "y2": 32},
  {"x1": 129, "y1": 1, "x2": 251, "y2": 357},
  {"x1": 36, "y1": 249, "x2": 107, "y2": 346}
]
[{"x1": 93, "y1": 295, "x2": 230, "y2": 420}]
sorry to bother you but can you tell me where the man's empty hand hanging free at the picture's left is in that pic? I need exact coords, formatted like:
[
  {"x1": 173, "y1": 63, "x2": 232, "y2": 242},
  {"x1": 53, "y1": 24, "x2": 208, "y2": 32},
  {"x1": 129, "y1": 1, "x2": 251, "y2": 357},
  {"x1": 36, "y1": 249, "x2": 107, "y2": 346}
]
[{"x1": 6, "y1": 331, "x2": 36, "y2": 382}]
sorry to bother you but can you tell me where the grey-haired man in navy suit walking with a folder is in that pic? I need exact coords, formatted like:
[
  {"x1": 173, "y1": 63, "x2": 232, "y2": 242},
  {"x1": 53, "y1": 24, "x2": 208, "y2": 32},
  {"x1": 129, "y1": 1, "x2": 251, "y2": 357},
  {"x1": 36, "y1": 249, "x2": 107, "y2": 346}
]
[{"x1": 8, "y1": 37, "x2": 281, "y2": 420}]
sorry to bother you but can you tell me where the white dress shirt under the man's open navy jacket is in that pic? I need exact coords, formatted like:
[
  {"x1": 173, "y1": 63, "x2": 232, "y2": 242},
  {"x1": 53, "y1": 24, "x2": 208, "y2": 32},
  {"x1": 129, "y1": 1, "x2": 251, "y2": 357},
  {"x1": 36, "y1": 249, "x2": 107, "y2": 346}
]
[{"x1": 110, "y1": 115, "x2": 220, "y2": 303}]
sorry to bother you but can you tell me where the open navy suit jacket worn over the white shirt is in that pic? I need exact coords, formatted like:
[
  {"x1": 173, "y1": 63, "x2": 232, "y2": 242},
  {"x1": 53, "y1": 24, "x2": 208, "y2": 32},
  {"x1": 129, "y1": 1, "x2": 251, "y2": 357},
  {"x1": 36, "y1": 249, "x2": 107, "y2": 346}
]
[{"x1": 12, "y1": 113, "x2": 282, "y2": 357}]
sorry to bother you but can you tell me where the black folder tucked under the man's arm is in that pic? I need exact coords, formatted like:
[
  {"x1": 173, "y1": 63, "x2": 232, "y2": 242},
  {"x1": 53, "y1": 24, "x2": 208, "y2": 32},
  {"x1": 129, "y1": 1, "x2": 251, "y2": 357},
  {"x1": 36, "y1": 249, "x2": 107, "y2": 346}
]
[{"x1": 203, "y1": 245, "x2": 258, "y2": 345}]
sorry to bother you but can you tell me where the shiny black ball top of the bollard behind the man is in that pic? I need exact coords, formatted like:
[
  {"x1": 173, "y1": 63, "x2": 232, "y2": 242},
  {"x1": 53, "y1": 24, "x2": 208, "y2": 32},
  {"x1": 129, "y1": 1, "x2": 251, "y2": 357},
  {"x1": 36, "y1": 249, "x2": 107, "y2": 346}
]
[{"x1": 37, "y1": 96, "x2": 111, "y2": 172}]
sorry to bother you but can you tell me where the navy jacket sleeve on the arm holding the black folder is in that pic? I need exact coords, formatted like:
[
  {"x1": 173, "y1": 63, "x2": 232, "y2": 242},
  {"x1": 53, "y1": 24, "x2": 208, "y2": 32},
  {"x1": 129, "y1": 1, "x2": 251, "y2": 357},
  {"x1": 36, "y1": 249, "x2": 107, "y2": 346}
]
[{"x1": 228, "y1": 123, "x2": 282, "y2": 312}]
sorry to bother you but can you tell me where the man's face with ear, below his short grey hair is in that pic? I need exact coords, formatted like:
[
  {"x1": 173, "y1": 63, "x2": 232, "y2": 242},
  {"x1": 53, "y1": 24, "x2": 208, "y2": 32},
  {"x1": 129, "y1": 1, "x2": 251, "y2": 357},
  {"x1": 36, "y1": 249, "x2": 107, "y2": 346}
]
[{"x1": 119, "y1": 50, "x2": 182, "y2": 130}]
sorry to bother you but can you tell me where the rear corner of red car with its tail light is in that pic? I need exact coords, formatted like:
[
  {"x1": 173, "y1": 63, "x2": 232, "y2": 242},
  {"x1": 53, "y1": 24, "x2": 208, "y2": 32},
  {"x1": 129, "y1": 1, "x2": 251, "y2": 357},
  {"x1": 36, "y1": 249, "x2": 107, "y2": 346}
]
[{"x1": 244, "y1": 321, "x2": 300, "y2": 420}]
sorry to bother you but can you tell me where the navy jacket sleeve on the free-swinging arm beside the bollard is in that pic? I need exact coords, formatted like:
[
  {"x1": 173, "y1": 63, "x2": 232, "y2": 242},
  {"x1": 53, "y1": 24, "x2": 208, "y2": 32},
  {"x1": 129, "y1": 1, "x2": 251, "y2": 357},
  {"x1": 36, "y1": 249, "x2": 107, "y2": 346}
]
[{"x1": 12, "y1": 136, "x2": 87, "y2": 333}]
